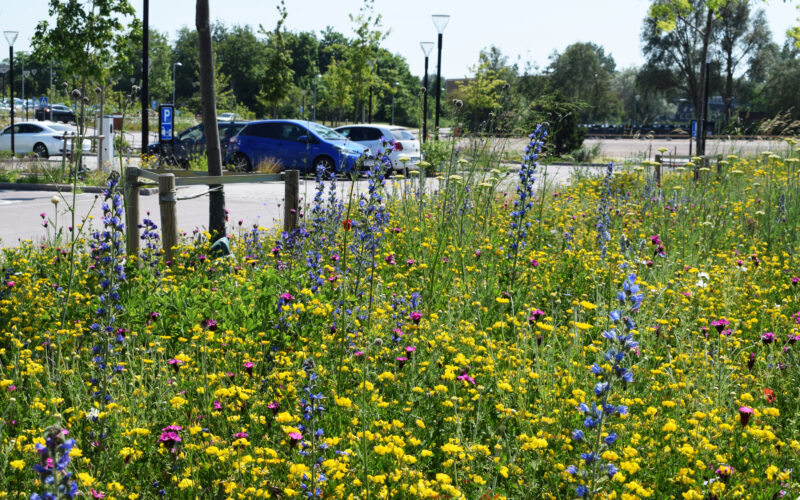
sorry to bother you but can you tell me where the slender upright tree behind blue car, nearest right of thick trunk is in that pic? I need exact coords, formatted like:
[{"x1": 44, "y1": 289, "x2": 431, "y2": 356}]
[{"x1": 258, "y1": 0, "x2": 293, "y2": 118}]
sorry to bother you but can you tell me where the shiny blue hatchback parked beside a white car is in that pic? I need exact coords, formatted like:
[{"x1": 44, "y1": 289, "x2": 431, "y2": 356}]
[{"x1": 225, "y1": 120, "x2": 369, "y2": 175}]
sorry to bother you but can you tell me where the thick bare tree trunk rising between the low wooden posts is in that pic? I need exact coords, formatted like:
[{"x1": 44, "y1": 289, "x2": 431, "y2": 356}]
[{"x1": 195, "y1": 0, "x2": 225, "y2": 241}]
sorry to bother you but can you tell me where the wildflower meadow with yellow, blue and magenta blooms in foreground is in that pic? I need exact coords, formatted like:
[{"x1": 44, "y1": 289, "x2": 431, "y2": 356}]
[{"x1": 0, "y1": 131, "x2": 800, "y2": 500}]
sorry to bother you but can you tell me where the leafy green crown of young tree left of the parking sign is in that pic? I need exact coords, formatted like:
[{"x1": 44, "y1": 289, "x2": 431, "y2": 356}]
[{"x1": 32, "y1": 0, "x2": 141, "y2": 86}]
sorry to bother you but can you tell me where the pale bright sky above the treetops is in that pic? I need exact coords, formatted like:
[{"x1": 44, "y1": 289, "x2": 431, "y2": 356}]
[{"x1": 0, "y1": 0, "x2": 800, "y2": 78}]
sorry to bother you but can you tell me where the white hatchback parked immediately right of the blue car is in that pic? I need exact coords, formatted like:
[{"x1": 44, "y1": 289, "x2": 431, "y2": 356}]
[{"x1": 335, "y1": 123, "x2": 420, "y2": 172}]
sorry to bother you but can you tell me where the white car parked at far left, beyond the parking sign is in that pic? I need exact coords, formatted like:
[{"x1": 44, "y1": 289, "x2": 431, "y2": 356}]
[{"x1": 0, "y1": 122, "x2": 92, "y2": 158}]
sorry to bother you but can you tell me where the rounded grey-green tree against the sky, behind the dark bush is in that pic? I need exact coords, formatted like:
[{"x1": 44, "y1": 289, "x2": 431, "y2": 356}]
[{"x1": 548, "y1": 42, "x2": 618, "y2": 121}]
